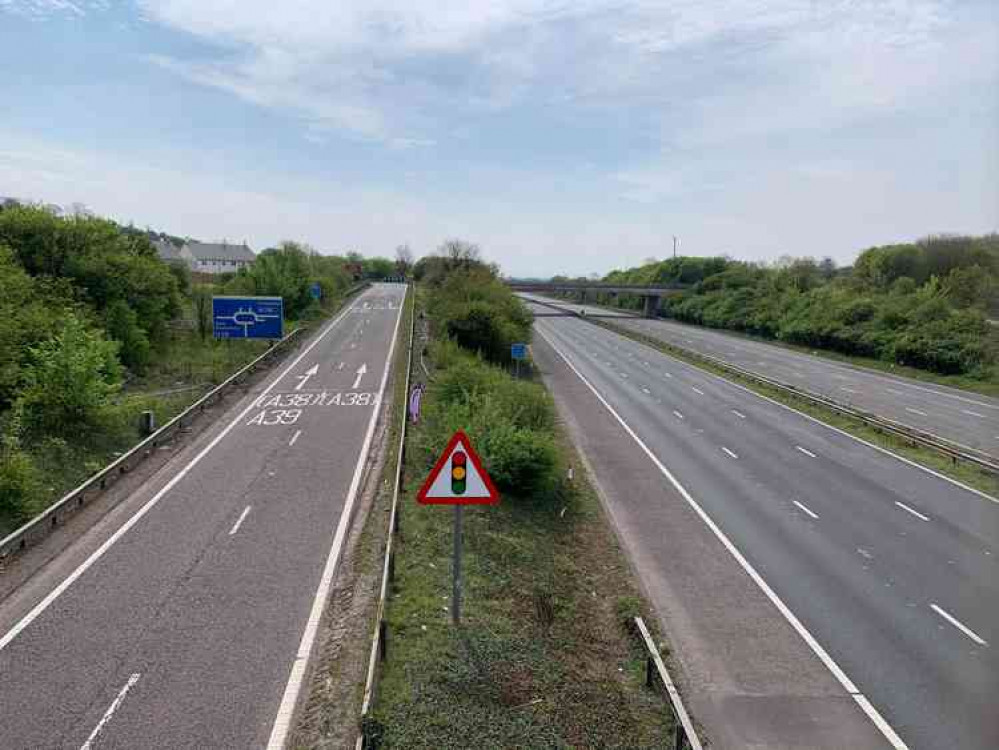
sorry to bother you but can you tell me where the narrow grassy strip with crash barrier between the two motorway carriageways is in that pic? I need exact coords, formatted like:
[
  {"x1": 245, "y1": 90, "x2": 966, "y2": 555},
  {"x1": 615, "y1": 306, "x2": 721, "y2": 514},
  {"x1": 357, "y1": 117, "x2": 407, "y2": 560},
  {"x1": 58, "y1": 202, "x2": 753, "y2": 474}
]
[{"x1": 589, "y1": 318, "x2": 999, "y2": 497}]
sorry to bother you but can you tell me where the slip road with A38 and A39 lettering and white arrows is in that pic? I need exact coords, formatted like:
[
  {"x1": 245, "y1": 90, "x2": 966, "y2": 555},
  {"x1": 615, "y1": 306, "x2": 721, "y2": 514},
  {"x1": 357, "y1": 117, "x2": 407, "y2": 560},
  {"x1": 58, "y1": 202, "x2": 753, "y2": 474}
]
[{"x1": 0, "y1": 284, "x2": 405, "y2": 750}]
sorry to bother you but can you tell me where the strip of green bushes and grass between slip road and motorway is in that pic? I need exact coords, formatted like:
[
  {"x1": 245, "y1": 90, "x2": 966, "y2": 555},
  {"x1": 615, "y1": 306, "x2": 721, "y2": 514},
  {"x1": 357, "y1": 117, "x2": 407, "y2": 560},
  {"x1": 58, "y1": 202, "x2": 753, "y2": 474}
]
[{"x1": 365, "y1": 257, "x2": 671, "y2": 750}]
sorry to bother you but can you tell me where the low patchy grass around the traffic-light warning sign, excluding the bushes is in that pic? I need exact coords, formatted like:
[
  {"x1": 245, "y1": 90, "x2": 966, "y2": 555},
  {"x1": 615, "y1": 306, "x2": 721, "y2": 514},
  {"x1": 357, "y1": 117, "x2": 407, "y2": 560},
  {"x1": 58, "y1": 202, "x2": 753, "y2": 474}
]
[{"x1": 370, "y1": 296, "x2": 672, "y2": 750}]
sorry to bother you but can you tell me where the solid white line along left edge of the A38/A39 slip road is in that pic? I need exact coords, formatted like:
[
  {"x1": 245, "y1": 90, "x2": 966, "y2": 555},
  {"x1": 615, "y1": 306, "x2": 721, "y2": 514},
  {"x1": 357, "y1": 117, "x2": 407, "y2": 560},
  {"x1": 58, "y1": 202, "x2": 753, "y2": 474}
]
[{"x1": 0, "y1": 290, "x2": 366, "y2": 651}]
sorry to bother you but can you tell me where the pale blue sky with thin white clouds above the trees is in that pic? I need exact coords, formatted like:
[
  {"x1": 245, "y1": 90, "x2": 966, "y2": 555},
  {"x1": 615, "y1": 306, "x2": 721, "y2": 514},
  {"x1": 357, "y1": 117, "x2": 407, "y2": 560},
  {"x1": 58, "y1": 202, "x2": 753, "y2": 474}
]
[{"x1": 0, "y1": 0, "x2": 999, "y2": 276}]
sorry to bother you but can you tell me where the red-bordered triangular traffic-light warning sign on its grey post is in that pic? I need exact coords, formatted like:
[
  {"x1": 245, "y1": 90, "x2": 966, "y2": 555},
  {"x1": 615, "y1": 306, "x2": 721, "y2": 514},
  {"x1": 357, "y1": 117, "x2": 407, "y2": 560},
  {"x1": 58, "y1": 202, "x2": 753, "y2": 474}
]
[{"x1": 416, "y1": 430, "x2": 499, "y2": 625}]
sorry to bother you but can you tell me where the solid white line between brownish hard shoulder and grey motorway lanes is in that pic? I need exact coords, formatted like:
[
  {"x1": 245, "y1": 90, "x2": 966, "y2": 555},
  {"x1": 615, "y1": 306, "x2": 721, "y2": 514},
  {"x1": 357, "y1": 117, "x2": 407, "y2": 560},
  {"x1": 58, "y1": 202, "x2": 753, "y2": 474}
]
[{"x1": 537, "y1": 328, "x2": 907, "y2": 750}]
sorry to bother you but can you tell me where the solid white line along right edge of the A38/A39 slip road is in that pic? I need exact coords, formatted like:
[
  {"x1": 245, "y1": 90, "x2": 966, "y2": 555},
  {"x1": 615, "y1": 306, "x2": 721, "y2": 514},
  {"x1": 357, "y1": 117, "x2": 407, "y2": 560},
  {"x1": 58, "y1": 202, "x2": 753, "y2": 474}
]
[{"x1": 267, "y1": 288, "x2": 408, "y2": 750}]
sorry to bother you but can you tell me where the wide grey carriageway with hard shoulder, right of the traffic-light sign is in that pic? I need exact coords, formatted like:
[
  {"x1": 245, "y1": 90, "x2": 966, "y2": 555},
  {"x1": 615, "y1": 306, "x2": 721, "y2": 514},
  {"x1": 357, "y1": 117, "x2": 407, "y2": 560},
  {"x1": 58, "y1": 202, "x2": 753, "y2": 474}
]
[{"x1": 534, "y1": 302, "x2": 999, "y2": 750}]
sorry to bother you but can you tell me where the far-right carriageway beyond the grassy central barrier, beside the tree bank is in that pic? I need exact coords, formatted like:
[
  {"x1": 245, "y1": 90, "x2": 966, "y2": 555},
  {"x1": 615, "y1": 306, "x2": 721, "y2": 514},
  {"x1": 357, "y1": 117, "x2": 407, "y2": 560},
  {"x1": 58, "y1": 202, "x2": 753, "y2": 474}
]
[{"x1": 522, "y1": 294, "x2": 999, "y2": 457}]
